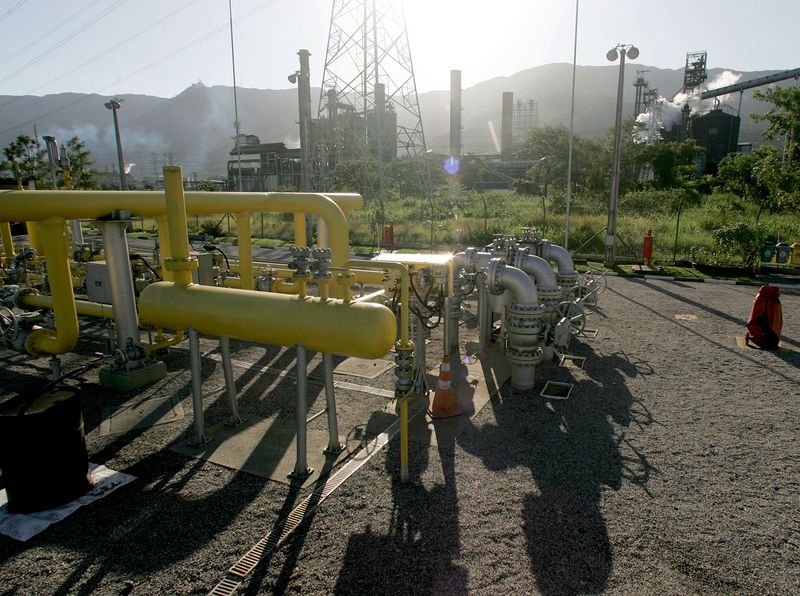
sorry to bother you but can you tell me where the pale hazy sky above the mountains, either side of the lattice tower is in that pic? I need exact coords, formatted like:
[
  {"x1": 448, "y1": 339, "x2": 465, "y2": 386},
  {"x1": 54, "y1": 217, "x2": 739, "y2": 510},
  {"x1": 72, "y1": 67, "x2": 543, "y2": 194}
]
[{"x1": 0, "y1": 0, "x2": 800, "y2": 97}]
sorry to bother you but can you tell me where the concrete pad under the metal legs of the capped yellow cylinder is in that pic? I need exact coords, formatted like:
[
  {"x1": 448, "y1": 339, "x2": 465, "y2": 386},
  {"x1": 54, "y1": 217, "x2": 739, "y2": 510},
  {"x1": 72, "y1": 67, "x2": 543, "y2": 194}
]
[{"x1": 170, "y1": 418, "x2": 347, "y2": 486}]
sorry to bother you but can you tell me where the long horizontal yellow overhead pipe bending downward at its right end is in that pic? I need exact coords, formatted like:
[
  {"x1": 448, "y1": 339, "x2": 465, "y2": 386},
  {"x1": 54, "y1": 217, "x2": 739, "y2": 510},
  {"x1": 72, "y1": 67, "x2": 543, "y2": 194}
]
[{"x1": 0, "y1": 189, "x2": 349, "y2": 267}]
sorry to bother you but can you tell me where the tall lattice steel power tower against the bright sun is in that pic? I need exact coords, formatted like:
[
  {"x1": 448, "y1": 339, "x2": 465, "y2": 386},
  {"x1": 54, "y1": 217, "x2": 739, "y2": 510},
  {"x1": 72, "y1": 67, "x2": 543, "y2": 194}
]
[{"x1": 312, "y1": 0, "x2": 426, "y2": 190}]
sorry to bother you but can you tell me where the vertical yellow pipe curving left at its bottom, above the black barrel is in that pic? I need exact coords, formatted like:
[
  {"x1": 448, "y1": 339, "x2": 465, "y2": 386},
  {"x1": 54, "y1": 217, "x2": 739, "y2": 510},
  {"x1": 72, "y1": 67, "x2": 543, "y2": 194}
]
[{"x1": 25, "y1": 217, "x2": 78, "y2": 356}]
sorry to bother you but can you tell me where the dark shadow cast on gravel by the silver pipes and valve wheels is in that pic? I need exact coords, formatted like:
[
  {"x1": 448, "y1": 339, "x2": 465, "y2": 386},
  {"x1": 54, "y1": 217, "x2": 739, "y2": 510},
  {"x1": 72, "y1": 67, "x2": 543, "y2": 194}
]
[{"x1": 458, "y1": 345, "x2": 653, "y2": 594}]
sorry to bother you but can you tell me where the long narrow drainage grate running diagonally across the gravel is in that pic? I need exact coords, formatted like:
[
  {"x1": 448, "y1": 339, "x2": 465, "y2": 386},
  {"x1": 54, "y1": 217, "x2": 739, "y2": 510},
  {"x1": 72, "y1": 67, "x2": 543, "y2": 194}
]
[{"x1": 209, "y1": 410, "x2": 398, "y2": 596}]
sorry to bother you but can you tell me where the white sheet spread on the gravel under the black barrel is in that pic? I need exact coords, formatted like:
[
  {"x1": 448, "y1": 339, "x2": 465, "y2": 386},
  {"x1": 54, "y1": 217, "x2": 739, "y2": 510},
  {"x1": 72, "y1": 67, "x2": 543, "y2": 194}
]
[{"x1": 0, "y1": 463, "x2": 136, "y2": 542}]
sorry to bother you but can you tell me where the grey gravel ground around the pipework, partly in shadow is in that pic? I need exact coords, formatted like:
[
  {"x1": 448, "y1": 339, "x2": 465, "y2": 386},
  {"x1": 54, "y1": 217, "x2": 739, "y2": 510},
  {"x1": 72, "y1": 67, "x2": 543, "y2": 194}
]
[{"x1": 0, "y1": 278, "x2": 800, "y2": 595}]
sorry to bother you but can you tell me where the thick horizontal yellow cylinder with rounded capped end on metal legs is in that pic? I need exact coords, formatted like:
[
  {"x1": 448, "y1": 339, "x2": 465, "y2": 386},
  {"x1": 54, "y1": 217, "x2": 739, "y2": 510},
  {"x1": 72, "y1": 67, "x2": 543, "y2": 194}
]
[{"x1": 139, "y1": 282, "x2": 397, "y2": 358}]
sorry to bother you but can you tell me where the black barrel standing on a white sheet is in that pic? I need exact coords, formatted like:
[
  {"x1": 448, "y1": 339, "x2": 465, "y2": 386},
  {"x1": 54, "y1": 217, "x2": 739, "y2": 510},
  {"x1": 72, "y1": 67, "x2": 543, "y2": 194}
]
[{"x1": 0, "y1": 385, "x2": 91, "y2": 513}]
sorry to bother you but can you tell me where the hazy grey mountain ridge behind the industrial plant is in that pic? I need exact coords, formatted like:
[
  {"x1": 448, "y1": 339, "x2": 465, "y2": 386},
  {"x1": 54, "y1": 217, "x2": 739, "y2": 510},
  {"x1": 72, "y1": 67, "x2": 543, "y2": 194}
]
[{"x1": 0, "y1": 62, "x2": 781, "y2": 177}]
